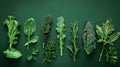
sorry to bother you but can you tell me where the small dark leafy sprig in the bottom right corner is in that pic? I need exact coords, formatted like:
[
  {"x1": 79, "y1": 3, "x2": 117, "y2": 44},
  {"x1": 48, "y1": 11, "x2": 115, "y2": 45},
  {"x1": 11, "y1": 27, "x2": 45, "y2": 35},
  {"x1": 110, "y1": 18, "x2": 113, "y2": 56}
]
[{"x1": 106, "y1": 46, "x2": 118, "y2": 64}]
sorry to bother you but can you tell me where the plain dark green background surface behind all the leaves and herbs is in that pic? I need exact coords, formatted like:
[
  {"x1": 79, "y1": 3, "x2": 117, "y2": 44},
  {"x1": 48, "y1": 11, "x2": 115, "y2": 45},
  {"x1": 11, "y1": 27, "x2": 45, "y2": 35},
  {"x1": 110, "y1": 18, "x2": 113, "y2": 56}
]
[{"x1": 0, "y1": 0, "x2": 120, "y2": 67}]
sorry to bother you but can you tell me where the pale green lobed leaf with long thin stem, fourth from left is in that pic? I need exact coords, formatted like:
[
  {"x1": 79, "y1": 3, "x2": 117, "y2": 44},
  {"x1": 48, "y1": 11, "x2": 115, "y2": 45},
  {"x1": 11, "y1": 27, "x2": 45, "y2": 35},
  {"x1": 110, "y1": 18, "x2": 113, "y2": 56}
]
[{"x1": 56, "y1": 16, "x2": 66, "y2": 56}]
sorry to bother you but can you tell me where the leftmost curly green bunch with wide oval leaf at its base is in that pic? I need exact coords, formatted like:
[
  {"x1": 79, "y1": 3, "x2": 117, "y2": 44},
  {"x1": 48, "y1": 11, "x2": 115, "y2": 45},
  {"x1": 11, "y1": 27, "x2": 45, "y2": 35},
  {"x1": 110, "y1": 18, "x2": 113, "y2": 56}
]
[{"x1": 3, "y1": 16, "x2": 22, "y2": 59}]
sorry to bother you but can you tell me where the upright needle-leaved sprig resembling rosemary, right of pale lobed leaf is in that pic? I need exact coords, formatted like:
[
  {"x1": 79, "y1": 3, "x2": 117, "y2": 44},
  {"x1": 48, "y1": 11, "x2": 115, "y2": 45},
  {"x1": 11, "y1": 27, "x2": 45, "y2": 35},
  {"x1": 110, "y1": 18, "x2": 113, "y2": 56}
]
[{"x1": 67, "y1": 22, "x2": 80, "y2": 62}]
